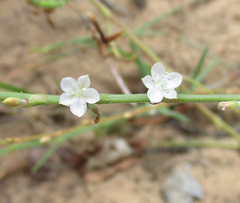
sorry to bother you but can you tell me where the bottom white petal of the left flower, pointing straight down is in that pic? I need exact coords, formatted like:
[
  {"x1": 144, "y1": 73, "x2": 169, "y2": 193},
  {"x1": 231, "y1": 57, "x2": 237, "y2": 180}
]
[{"x1": 70, "y1": 97, "x2": 87, "y2": 117}]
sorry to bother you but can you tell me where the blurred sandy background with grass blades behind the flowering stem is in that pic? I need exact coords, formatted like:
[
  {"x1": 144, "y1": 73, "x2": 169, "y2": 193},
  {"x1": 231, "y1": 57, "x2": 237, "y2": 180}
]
[{"x1": 0, "y1": 0, "x2": 240, "y2": 203}]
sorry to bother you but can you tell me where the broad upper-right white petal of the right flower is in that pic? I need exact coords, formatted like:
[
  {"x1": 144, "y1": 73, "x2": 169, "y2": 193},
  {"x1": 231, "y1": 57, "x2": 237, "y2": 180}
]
[{"x1": 164, "y1": 72, "x2": 182, "y2": 89}]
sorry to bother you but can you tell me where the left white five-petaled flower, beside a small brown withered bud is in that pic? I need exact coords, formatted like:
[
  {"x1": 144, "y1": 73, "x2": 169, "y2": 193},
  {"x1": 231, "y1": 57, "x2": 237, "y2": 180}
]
[{"x1": 59, "y1": 75, "x2": 100, "y2": 117}]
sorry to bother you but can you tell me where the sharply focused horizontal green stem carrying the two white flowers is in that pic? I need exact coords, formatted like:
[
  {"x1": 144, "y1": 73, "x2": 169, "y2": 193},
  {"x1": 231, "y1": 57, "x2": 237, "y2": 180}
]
[{"x1": 0, "y1": 92, "x2": 240, "y2": 107}]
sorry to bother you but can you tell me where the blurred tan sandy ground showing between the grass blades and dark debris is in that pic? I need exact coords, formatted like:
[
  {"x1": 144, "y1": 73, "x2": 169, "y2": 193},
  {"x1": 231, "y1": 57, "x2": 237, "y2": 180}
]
[{"x1": 0, "y1": 0, "x2": 240, "y2": 203}]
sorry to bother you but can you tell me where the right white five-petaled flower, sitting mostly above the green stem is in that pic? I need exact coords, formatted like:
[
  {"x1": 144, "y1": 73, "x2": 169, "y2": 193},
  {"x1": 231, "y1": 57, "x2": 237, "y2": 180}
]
[{"x1": 142, "y1": 62, "x2": 182, "y2": 103}]
